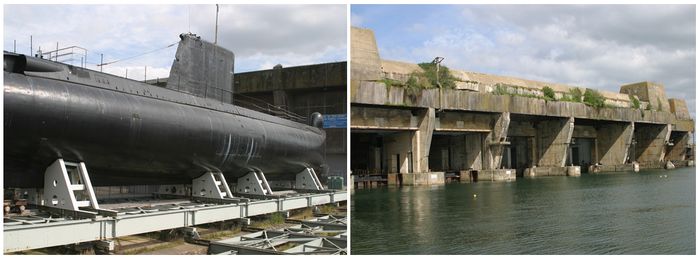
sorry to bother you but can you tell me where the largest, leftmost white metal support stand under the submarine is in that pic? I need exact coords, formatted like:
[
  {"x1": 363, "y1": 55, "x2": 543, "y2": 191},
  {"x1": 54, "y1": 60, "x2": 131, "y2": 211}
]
[{"x1": 44, "y1": 159, "x2": 100, "y2": 211}]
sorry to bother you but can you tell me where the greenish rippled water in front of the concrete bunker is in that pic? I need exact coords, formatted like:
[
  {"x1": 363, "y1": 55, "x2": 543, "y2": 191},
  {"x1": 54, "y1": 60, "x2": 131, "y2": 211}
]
[{"x1": 350, "y1": 167, "x2": 696, "y2": 255}]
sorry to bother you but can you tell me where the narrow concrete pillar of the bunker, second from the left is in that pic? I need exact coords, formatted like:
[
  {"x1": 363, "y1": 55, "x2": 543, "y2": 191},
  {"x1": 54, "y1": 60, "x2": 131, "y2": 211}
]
[{"x1": 484, "y1": 112, "x2": 510, "y2": 169}]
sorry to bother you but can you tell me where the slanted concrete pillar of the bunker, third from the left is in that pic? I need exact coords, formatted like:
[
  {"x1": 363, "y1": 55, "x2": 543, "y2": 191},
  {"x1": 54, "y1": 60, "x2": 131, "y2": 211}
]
[{"x1": 537, "y1": 117, "x2": 574, "y2": 167}]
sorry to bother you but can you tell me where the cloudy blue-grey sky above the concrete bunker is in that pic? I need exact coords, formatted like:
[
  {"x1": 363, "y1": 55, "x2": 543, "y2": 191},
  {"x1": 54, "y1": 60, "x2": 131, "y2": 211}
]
[{"x1": 350, "y1": 5, "x2": 696, "y2": 118}]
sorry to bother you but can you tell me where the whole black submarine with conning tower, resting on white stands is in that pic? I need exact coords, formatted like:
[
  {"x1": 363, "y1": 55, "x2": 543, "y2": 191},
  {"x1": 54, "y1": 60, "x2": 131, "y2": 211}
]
[{"x1": 3, "y1": 33, "x2": 327, "y2": 188}]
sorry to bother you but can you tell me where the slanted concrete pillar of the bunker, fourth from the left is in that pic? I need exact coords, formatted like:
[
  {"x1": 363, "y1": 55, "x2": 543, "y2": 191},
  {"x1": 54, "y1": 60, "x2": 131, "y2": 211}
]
[{"x1": 595, "y1": 122, "x2": 634, "y2": 165}]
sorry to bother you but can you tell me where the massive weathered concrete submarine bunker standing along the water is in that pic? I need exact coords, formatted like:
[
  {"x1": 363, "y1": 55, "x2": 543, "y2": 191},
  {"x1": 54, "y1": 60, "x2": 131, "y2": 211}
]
[{"x1": 350, "y1": 27, "x2": 695, "y2": 184}]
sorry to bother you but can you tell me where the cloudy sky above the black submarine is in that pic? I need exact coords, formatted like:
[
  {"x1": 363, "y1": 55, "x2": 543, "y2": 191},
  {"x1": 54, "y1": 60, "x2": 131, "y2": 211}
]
[{"x1": 3, "y1": 4, "x2": 348, "y2": 80}]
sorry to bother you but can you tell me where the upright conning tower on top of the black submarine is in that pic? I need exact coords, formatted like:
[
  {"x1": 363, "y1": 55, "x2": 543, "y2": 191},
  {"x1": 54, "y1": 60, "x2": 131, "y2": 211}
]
[{"x1": 166, "y1": 33, "x2": 234, "y2": 104}]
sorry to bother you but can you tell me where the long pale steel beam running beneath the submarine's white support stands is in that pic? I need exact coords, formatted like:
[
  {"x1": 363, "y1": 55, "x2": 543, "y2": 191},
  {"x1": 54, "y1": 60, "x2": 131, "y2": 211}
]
[{"x1": 3, "y1": 191, "x2": 348, "y2": 253}]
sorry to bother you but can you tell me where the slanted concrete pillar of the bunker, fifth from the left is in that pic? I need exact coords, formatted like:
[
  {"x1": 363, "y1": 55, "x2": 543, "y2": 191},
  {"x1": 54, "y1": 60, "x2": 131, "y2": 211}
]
[{"x1": 634, "y1": 124, "x2": 672, "y2": 162}]
